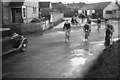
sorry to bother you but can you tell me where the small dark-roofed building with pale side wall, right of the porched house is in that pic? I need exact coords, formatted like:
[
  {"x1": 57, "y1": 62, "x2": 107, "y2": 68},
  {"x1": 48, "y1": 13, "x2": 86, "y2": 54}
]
[{"x1": 39, "y1": 2, "x2": 64, "y2": 23}]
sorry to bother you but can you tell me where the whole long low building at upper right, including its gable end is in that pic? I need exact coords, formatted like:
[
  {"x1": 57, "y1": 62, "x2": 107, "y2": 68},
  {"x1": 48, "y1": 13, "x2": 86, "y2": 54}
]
[{"x1": 79, "y1": 2, "x2": 118, "y2": 18}]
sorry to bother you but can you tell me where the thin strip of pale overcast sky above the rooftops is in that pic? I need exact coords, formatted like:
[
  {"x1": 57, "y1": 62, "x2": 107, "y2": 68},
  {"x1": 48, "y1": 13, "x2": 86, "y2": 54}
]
[{"x1": 40, "y1": 0, "x2": 120, "y2": 3}]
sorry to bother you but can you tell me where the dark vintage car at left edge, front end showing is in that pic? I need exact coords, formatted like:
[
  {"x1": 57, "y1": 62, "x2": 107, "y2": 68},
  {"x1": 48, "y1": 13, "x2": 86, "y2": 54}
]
[{"x1": 0, "y1": 28, "x2": 28, "y2": 55}]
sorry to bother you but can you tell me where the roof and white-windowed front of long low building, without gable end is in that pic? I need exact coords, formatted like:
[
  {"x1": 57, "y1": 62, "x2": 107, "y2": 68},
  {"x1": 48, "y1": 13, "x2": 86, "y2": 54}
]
[{"x1": 79, "y1": 2, "x2": 111, "y2": 17}]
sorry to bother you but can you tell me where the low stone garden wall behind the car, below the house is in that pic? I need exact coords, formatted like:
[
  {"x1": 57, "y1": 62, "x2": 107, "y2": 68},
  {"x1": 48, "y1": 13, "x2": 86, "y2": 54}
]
[{"x1": 4, "y1": 23, "x2": 43, "y2": 35}]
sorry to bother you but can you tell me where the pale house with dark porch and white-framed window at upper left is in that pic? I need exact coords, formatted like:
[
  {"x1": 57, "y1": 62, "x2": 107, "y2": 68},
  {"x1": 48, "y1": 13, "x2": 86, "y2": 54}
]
[{"x1": 3, "y1": 0, "x2": 39, "y2": 24}]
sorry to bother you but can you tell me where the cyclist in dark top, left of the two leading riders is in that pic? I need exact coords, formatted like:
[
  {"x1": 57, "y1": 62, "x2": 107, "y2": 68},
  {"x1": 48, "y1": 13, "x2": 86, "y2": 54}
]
[{"x1": 63, "y1": 20, "x2": 71, "y2": 41}]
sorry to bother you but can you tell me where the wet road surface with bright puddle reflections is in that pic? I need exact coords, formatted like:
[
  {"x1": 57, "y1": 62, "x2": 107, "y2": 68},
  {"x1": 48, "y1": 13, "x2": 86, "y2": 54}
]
[{"x1": 2, "y1": 18, "x2": 118, "y2": 78}]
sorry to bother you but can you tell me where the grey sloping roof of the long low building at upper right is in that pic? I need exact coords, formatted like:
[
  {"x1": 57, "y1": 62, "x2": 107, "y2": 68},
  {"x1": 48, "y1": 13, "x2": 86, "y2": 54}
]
[{"x1": 80, "y1": 2, "x2": 111, "y2": 10}]
